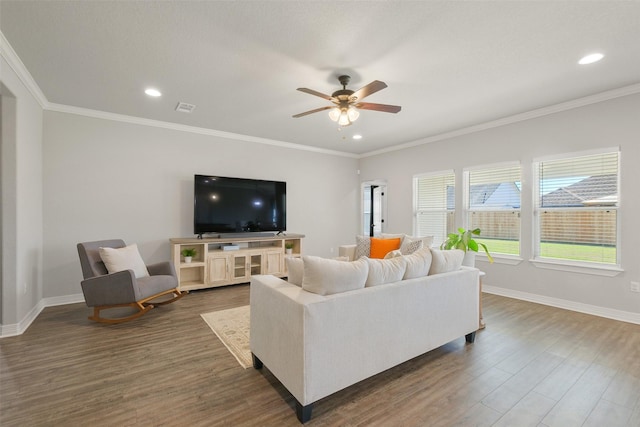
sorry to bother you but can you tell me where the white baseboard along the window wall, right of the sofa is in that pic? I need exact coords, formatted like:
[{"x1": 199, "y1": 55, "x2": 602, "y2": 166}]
[{"x1": 482, "y1": 284, "x2": 640, "y2": 325}]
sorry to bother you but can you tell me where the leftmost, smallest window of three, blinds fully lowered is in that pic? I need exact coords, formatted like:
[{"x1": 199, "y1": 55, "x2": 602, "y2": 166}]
[{"x1": 413, "y1": 171, "x2": 455, "y2": 245}]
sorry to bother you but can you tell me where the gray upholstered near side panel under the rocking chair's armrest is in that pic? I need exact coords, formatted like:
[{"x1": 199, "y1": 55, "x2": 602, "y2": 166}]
[{"x1": 80, "y1": 270, "x2": 137, "y2": 307}]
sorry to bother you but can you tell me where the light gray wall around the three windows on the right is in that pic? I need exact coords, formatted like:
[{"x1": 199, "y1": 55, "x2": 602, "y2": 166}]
[{"x1": 360, "y1": 94, "x2": 640, "y2": 313}]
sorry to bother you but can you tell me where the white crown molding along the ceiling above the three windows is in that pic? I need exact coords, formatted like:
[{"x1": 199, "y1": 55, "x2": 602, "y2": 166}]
[{"x1": 360, "y1": 83, "x2": 640, "y2": 159}]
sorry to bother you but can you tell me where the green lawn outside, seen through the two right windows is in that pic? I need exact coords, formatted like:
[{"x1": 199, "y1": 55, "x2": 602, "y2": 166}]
[{"x1": 475, "y1": 239, "x2": 616, "y2": 264}]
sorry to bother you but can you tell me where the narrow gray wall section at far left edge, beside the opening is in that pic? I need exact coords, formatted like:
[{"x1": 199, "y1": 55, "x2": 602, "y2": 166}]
[{"x1": 0, "y1": 56, "x2": 42, "y2": 325}]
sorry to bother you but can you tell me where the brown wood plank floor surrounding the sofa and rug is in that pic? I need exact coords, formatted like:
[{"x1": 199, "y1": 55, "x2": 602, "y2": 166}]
[{"x1": 0, "y1": 285, "x2": 640, "y2": 427}]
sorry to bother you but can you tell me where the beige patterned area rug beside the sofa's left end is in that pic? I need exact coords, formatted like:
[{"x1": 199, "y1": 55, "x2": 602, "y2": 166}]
[{"x1": 200, "y1": 305, "x2": 253, "y2": 369}]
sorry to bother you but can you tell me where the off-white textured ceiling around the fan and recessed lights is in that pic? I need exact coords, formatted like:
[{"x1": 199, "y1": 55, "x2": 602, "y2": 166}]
[{"x1": 0, "y1": 0, "x2": 640, "y2": 154}]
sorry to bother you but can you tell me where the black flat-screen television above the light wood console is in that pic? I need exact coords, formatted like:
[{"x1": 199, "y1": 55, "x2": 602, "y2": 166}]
[{"x1": 193, "y1": 175, "x2": 287, "y2": 236}]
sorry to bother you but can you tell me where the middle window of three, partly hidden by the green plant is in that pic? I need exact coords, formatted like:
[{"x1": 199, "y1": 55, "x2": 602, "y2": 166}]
[{"x1": 465, "y1": 163, "x2": 521, "y2": 256}]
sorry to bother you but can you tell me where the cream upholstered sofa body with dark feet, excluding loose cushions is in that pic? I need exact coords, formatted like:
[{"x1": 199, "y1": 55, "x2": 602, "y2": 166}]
[{"x1": 250, "y1": 267, "x2": 479, "y2": 423}]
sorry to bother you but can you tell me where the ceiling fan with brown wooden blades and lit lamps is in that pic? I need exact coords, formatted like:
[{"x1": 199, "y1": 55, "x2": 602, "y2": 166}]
[{"x1": 293, "y1": 75, "x2": 402, "y2": 126}]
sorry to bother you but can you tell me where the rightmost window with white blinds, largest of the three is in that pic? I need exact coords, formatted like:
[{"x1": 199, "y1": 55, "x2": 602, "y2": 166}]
[{"x1": 534, "y1": 149, "x2": 620, "y2": 265}]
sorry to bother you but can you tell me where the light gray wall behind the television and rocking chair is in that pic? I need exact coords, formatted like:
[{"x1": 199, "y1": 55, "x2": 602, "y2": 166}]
[{"x1": 43, "y1": 111, "x2": 359, "y2": 297}]
